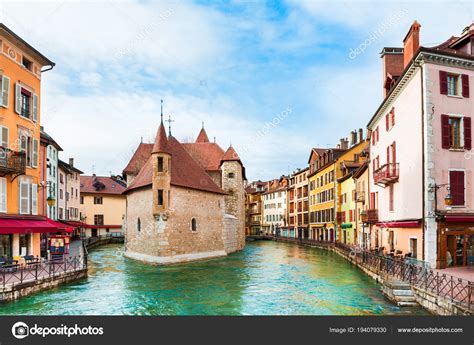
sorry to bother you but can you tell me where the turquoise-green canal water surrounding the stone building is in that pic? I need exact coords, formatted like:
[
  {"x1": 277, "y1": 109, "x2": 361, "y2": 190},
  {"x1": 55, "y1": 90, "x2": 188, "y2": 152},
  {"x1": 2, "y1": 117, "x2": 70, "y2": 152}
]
[{"x1": 0, "y1": 241, "x2": 426, "y2": 315}]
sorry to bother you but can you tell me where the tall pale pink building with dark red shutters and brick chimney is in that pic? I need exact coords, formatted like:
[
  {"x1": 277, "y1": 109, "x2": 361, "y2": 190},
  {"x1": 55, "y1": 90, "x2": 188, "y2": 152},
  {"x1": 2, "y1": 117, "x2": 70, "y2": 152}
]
[{"x1": 368, "y1": 22, "x2": 474, "y2": 268}]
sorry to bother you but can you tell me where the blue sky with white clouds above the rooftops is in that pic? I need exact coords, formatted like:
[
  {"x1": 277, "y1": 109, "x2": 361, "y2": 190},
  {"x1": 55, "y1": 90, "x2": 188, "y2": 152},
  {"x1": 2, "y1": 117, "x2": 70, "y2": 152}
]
[{"x1": 0, "y1": 0, "x2": 474, "y2": 181}]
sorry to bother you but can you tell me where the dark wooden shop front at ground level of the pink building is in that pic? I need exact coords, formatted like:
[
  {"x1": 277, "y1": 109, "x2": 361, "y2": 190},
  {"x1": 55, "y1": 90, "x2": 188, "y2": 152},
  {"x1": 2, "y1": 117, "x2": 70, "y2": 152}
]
[{"x1": 437, "y1": 216, "x2": 474, "y2": 268}]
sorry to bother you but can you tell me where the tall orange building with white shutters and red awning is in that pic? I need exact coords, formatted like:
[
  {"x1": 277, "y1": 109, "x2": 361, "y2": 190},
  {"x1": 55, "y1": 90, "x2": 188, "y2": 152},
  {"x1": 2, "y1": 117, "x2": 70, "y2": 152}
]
[{"x1": 0, "y1": 23, "x2": 64, "y2": 260}]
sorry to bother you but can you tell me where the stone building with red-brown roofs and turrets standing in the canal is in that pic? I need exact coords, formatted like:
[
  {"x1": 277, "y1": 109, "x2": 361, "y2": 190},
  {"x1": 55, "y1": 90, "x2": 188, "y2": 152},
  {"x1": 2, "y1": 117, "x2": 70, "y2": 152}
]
[{"x1": 124, "y1": 118, "x2": 245, "y2": 264}]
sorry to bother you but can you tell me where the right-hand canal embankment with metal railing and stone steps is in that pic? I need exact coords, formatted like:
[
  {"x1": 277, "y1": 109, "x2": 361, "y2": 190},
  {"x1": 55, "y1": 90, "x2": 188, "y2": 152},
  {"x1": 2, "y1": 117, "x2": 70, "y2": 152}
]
[{"x1": 262, "y1": 236, "x2": 474, "y2": 315}]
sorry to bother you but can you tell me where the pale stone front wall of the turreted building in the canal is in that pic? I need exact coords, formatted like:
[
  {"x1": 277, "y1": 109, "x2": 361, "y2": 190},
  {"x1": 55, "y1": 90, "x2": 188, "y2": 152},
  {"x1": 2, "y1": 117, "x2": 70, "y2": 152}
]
[{"x1": 126, "y1": 186, "x2": 226, "y2": 264}]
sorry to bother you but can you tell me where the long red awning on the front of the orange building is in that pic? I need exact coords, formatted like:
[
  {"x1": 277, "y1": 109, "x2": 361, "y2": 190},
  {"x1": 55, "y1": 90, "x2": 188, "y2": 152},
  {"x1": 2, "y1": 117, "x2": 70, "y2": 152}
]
[{"x1": 0, "y1": 218, "x2": 72, "y2": 235}]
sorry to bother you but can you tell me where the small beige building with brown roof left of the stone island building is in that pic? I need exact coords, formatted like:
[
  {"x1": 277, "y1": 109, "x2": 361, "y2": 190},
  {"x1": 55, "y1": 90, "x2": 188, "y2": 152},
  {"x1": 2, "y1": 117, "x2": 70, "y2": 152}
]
[{"x1": 80, "y1": 175, "x2": 126, "y2": 237}]
